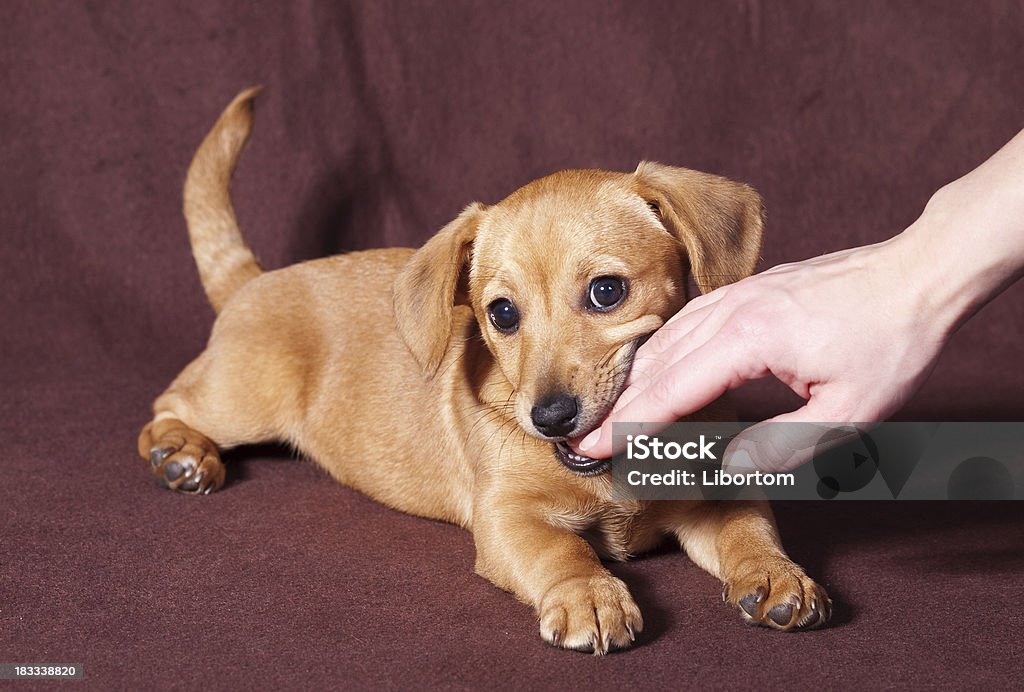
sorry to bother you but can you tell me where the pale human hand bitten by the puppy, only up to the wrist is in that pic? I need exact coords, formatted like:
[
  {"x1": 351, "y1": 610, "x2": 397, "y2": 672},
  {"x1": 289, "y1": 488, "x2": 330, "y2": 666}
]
[{"x1": 578, "y1": 236, "x2": 953, "y2": 472}]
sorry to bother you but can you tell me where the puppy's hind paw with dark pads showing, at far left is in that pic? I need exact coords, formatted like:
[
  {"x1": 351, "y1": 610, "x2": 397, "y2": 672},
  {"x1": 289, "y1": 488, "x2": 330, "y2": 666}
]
[{"x1": 143, "y1": 428, "x2": 226, "y2": 494}]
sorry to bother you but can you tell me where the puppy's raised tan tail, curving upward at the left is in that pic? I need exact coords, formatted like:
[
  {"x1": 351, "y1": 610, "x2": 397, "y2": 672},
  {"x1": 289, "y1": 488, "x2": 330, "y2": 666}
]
[{"x1": 184, "y1": 87, "x2": 263, "y2": 312}]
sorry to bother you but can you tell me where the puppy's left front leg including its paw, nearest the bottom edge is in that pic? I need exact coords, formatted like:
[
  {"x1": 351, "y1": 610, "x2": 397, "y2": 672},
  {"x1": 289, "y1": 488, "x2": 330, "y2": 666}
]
[{"x1": 473, "y1": 502, "x2": 643, "y2": 655}]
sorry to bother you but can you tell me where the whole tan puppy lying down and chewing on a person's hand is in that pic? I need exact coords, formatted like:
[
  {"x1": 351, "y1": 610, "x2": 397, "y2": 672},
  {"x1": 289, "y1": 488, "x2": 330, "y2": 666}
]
[{"x1": 138, "y1": 89, "x2": 830, "y2": 654}]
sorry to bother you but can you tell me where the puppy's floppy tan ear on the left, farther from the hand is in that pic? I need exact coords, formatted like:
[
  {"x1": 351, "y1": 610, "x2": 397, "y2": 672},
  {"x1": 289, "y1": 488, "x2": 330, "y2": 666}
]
[{"x1": 392, "y1": 204, "x2": 484, "y2": 376}]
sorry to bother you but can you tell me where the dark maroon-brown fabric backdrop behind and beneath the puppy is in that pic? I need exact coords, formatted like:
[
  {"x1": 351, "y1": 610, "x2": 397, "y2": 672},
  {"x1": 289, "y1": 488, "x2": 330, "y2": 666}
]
[{"x1": 0, "y1": 0, "x2": 1024, "y2": 689}]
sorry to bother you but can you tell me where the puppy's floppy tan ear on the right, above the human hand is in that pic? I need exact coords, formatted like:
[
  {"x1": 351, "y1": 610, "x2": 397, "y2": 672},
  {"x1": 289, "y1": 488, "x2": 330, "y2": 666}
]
[{"x1": 635, "y1": 161, "x2": 764, "y2": 293}]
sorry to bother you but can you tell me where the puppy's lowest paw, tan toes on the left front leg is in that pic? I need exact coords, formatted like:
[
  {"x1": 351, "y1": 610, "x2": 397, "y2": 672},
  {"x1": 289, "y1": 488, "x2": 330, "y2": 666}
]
[{"x1": 538, "y1": 574, "x2": 643, "y2": 656}]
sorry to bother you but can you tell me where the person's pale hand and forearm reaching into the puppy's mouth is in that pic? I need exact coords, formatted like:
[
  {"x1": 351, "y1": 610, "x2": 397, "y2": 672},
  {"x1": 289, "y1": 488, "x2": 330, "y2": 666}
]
[{"x1": 573, "y1": 126, "x2": 1024, "y2": 471}]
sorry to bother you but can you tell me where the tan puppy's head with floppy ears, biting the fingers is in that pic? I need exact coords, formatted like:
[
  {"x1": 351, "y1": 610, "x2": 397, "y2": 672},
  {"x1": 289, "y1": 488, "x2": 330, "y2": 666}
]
[{"x1": 394, "y1": 163, "x2": 763, "y2": 475}]
